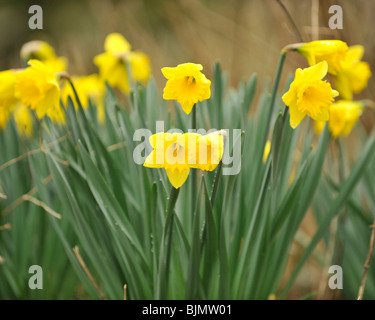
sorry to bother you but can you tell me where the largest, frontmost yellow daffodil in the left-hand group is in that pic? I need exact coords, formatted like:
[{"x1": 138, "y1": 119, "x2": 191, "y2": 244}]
[{"x1": 15, "y1": 60, "x2": 60, "y2": 119}]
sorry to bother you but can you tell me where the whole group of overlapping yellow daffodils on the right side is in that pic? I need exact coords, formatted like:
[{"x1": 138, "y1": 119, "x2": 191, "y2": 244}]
[{"x1": 282, "y1": 40, "x2": 371, "y2": 138}]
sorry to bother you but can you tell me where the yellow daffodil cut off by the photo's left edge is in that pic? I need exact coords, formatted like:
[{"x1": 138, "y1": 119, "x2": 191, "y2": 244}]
[{"x1": 0, "y1": 70, "x2": 17, "y2": 129}]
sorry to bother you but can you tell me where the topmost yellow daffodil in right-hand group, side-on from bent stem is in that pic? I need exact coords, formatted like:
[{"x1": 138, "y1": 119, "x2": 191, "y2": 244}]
[{"x1": 296, "y1": 40, "x2": 348, "y2": 75}]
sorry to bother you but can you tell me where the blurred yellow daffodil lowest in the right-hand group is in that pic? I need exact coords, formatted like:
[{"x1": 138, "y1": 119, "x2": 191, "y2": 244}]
[{"x1": 315, "y1": 100, "x2": 363, "y2": 139}]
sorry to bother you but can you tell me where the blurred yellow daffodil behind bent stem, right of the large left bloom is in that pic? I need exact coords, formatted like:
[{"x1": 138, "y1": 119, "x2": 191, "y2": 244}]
[{"x1": 61, "y1": 74, "x2": 105, "y2": 124}]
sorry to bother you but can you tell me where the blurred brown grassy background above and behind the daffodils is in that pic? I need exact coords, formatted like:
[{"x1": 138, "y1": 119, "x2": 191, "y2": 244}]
[{"x1": 0, "y1": 0, "x2": 375, "y2": 298}]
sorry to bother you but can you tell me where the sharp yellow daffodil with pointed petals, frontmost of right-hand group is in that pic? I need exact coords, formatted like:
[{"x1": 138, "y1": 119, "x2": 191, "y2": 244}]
[{"x1": 282, "y1": 61, "x2": 338, "y2": 129}]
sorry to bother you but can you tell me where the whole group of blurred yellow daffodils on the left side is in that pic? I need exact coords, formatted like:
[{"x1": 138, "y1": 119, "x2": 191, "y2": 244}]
[{"x1": 0, "y1": 33, "x2": 151, "y2": 137}]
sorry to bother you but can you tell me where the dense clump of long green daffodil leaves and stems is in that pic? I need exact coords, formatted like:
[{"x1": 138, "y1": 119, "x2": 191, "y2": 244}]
[{"x1": 0, "y1": 63, "x2": 375, "y2": 299}]
